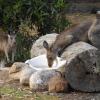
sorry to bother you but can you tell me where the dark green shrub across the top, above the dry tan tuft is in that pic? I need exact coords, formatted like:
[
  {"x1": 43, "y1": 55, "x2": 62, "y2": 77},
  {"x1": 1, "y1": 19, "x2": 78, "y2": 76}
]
[{"x1": 0, "y1": 0, "x2": 69, "y2": 34}]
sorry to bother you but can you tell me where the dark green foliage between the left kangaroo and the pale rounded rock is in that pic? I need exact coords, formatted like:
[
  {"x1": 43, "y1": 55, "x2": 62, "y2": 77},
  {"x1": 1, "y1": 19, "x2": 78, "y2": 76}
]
[{"x1": 15, "y1": 33, "x2": 37, "y2": 61}]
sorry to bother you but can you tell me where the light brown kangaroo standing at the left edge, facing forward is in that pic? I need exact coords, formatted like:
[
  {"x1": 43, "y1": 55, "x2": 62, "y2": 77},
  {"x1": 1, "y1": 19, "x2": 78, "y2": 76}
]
[{"x1": 0, "y1": 34, "x2": 16, "y2": 62}]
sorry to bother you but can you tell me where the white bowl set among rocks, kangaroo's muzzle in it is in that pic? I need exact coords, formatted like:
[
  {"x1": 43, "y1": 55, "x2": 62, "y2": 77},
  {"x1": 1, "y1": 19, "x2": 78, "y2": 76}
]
[{"x1": 25, "y1": 54, "x2": 66, "y2": 70}]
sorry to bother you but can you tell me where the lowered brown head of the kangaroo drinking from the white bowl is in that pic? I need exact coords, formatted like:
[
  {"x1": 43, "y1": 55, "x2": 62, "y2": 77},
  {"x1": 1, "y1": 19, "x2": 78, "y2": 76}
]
[{"x1": 43, "y1": 41, "x2": 57, "y2": 67}]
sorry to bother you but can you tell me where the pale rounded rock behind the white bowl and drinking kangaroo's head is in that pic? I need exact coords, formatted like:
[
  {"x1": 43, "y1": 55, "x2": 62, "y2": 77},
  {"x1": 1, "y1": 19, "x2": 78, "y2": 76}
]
[{"x1": 30, "y1": 33, "x2": 58, "y2": 58}]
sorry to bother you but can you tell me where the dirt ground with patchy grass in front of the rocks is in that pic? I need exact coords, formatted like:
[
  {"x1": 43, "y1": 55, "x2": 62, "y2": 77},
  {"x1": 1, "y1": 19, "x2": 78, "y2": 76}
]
[{"x1": 0, "y1": 71, "x2": 100, "y2": 100}]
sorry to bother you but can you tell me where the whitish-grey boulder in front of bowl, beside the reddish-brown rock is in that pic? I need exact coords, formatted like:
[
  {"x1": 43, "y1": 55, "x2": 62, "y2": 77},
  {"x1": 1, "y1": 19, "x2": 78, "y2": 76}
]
[{"x1": 29, "y1": 70, "x2": 61, "y2": 91}]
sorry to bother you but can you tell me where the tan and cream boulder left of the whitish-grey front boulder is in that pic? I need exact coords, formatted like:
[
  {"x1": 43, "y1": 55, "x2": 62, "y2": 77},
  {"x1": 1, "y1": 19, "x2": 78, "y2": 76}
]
[{"x1": 9, "y1": 62, "x2": 35, "y2": 85}]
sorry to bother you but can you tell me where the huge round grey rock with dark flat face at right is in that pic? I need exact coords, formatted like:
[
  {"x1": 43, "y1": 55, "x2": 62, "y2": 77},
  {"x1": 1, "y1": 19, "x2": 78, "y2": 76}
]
[{"x1": 62, "y1": 42, "x2": 100, "y2": 92}]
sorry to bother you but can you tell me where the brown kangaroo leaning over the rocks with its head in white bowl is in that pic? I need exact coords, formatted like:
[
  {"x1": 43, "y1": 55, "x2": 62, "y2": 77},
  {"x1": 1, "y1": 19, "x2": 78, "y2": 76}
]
[{"x1": 43, "y1": 21, "x2": 92, "y2": 67}]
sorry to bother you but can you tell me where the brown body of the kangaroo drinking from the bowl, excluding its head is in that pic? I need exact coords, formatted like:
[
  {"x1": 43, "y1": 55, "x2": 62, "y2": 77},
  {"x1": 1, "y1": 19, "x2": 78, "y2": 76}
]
[{"x1": 51, "y1": 21, "x2": 92, "y2": 54}]
